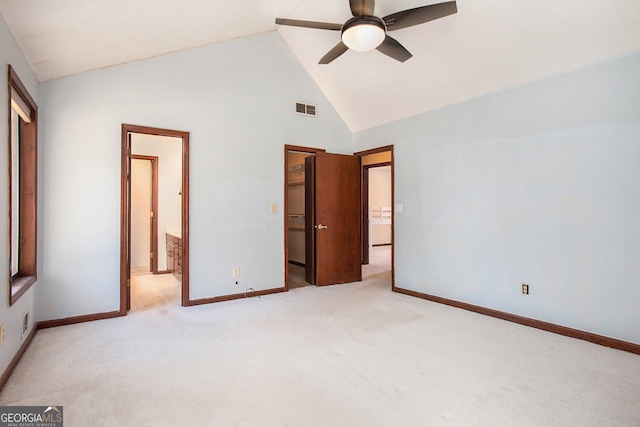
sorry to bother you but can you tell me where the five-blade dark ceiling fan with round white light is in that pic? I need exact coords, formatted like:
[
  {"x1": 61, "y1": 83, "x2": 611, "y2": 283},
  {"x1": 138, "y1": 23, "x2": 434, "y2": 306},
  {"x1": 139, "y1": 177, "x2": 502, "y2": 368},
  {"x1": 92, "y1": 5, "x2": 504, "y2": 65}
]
[{"x1": 276, "y1": 0, "x2": 458, "y2": 64}]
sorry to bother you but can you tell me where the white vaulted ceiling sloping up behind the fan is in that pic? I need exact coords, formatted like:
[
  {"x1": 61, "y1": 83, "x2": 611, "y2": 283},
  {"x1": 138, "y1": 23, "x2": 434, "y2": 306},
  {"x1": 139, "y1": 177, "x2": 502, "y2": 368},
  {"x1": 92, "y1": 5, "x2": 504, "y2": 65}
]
[{"x1": 0, "y1": 0, "x2": 640, "y2": 132}]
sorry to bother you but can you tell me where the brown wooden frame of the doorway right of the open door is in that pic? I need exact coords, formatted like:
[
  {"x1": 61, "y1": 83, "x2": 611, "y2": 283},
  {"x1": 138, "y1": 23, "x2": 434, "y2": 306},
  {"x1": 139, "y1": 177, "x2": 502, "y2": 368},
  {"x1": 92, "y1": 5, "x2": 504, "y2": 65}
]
[{"x1": 353, "y1": 145, "x2": 396, "y2": 289}]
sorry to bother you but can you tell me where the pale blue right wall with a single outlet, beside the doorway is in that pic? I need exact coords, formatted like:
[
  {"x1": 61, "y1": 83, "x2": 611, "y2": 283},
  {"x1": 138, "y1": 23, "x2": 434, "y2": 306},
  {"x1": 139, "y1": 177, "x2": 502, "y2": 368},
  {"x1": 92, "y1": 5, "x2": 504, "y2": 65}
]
[{"x1": 354, "y1": 53, "x2": 640, "y2": 343}]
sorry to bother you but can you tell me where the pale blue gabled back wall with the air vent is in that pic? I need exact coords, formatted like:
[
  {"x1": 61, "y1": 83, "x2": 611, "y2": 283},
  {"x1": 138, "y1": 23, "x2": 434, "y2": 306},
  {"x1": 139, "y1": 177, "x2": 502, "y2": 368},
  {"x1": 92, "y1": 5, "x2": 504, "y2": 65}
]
[{"x1": 38, "y1": 32, "x2": 352, "y2": 320}]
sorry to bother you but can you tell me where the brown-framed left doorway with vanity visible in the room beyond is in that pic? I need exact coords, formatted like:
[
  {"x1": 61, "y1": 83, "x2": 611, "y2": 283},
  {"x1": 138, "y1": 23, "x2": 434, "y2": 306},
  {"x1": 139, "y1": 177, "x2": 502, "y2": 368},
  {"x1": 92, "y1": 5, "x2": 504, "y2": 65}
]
[{"x1": 120, "y1": 124, "x2": 190, "y2": 315}]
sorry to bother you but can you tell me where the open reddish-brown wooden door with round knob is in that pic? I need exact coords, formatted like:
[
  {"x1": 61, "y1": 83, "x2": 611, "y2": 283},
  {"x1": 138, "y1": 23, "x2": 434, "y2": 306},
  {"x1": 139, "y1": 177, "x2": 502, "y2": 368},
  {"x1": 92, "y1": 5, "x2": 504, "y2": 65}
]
[{"x1": 305, "y1": 153, "x2": 362, "y2": 286}]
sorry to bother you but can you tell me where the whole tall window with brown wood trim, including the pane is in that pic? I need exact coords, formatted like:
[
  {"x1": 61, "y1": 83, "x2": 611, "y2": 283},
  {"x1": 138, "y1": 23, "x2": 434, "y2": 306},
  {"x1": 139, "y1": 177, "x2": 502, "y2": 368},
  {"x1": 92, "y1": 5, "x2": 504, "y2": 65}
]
[{"x1": 8, "y1": 65, "x2": 38, "y2": 305}]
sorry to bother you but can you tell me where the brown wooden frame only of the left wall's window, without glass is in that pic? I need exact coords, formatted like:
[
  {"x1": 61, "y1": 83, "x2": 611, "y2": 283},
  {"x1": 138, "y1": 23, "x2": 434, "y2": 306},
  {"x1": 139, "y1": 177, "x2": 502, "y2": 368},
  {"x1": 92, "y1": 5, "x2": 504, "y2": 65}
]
[{"x1": 7, "y1": 65, "x2": 38, "y2": 305}]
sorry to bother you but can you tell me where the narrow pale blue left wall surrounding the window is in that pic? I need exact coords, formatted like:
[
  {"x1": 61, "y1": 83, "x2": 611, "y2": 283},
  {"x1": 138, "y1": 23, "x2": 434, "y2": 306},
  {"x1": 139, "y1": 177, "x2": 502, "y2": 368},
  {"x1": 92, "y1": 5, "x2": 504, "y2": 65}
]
[{"x1": 0, "y1": 16, "x2": 42, "y2": 373}]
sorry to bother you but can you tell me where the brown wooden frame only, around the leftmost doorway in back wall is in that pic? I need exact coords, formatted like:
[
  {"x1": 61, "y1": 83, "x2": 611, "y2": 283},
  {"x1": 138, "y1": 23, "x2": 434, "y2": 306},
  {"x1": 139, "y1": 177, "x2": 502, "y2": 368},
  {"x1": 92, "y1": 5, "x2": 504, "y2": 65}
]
[{"x1": 119, "y1": 123, "x2": 191, "y2": 316}]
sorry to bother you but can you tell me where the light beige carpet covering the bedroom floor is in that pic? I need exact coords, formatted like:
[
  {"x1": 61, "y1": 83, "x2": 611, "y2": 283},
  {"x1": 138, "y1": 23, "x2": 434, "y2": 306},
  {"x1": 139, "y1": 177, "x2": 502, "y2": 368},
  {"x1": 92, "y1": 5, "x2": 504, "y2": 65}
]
[{"x1": 0, "y1": 249, "x2": 640, "y2": 427}]
